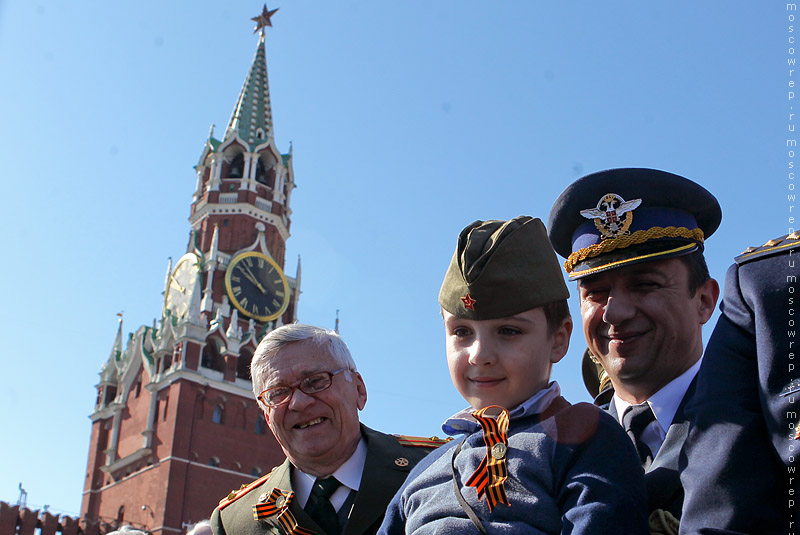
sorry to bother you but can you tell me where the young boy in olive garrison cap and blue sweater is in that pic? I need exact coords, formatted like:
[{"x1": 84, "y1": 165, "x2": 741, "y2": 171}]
[{"x1": 378, "y1": 216, "x2": 649, "y2": 535}]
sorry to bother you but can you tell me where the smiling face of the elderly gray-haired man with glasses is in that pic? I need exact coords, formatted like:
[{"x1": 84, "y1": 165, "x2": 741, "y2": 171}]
[{"x1": 264, "y1": 342, "x2": 367, "y2": 476}]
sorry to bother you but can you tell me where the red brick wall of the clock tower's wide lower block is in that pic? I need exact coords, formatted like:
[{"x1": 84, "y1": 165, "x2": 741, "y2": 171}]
[{"x1": 81, "y1": 379, "x2": 284, "y2": 535}]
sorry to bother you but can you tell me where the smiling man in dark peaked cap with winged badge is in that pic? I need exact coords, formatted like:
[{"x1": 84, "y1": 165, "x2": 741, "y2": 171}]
[{"x1": 548, "y1": 168, "x2": 722, "y2": 523}]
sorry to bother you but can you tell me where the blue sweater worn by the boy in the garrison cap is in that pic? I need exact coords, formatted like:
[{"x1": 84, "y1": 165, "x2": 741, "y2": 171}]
[{"x1": 378, "y1": 397, "x2": 650, "y2": 535}]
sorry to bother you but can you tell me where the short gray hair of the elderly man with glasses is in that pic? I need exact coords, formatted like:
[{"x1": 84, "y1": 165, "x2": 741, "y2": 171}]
[{"x1": 250, "y1": 323, "x2": 357, "y2": 404}]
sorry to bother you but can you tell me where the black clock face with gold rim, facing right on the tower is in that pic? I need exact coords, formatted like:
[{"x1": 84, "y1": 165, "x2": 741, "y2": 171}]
[{"x1": 225, "y1": 252, "x2": 289, "y2": 321}]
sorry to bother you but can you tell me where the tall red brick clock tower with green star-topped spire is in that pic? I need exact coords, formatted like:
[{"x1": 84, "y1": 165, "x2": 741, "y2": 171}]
[{"x1": 81, "y1": 5, "x2": 300, "y2": 535}]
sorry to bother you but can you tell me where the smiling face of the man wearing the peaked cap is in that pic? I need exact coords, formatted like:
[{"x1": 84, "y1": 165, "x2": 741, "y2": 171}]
[{"x1": 578, "y1": 258, "x2": 719, "y2": 402}]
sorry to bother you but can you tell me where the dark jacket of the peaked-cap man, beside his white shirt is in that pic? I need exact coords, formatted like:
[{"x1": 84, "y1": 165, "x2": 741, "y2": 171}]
[{"x1": 608, "y1": 386, "x2": 697, "y2": 519}]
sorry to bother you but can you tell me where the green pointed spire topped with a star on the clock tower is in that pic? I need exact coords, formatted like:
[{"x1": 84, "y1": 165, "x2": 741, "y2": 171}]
[{"x1": 225, "y1": 4, "x2": 278, "y2": 147}]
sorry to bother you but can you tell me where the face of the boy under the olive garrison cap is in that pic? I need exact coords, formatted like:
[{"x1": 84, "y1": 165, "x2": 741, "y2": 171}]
[{"x1": 442, "y1": 307, "x2": 572, "y2": 409}]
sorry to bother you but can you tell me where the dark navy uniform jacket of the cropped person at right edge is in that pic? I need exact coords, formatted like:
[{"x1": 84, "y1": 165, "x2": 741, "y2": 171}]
[{"x1": 681, "y1": 233, "x2": 800, "y2": 534}]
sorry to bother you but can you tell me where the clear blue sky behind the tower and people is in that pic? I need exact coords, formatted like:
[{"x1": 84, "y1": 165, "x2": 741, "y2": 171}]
[{"x1": 0, "y1": 0, "x2": 788, "y2": 514}]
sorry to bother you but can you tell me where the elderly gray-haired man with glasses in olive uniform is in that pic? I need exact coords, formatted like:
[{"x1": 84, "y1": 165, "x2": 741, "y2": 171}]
[{"x1": 211, "y1": 324, "x2": 441, "y2": 535}]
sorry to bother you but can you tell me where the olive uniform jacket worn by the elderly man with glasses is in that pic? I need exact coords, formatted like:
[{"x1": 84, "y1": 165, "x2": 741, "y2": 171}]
[{"x1": 211, "y1": 425, "x2": 438, "y2": 535}]
